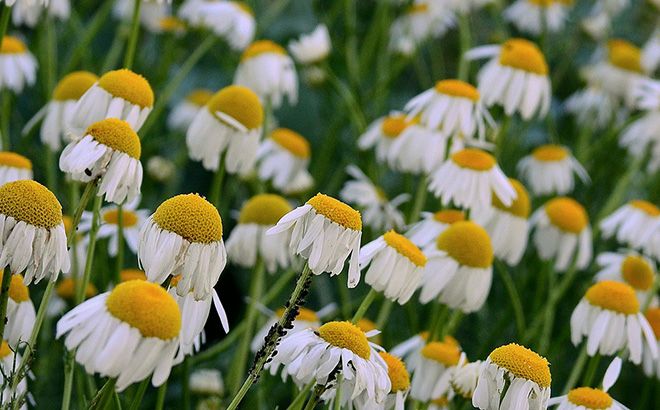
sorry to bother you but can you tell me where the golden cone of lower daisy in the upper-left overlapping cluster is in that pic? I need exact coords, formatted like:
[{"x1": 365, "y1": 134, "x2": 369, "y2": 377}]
[{"x1": 85, "y1": 118, "x2": 142, "y2": 159}]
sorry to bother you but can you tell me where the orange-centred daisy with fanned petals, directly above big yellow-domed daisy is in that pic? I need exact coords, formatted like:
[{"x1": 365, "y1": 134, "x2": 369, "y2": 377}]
[{"x1": 429, "y1": 148, "x2": 516, "y2": 209}]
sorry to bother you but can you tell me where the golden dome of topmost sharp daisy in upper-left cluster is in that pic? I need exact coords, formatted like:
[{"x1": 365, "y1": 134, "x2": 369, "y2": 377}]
[{"x1": 99, "y1": 68, "x2": 154, "y2": 108}]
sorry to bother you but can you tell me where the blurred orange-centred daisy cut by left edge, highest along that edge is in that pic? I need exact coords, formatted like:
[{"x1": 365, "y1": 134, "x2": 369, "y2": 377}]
[{"x1": 0, "y1": 35, "x2": 37, "y2": 94}]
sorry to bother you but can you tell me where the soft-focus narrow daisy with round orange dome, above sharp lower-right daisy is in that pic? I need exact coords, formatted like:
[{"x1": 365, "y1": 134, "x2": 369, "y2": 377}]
[{"x1": 530, "y1": 197, "x2": 593, "y2": 272}]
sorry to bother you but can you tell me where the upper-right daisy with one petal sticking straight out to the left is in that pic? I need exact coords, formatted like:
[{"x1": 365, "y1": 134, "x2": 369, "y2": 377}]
[{"x1": 466, "y1": 38, "x2": 551, "y2": 120}]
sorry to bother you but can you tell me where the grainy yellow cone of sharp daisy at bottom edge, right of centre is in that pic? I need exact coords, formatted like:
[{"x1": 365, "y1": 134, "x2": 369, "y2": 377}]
[{"x1": 489, "y1": 343, "x2": 552, "y2": 387}]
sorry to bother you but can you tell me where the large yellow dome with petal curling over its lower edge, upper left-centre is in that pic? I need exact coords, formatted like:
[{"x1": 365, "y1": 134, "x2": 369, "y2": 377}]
[{"x1": 206, "y1": 85, "x2": 264, "y2": 130}]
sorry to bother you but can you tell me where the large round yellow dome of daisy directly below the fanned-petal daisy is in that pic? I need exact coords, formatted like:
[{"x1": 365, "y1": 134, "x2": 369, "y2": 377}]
[{"x1": 437, "y1": 221, "x2": 493, "y2": 268}]
